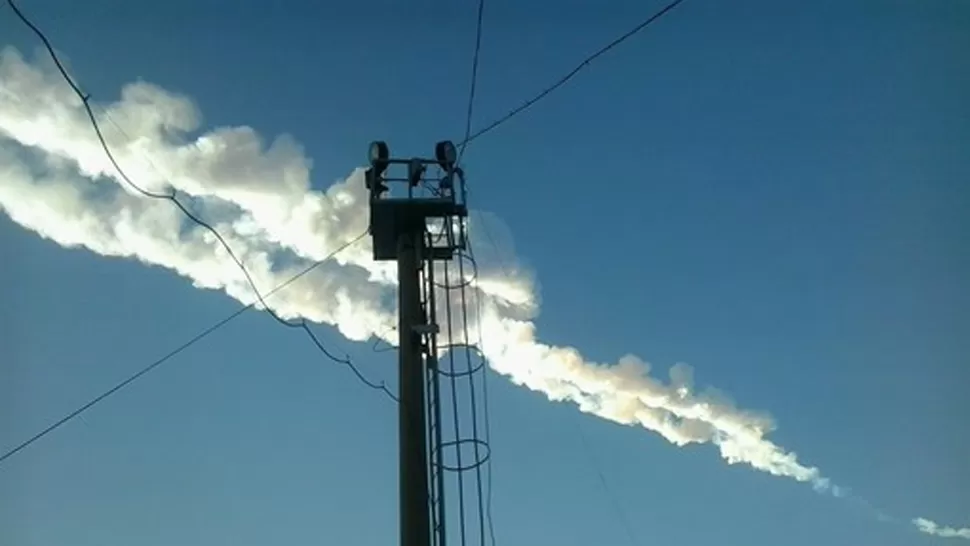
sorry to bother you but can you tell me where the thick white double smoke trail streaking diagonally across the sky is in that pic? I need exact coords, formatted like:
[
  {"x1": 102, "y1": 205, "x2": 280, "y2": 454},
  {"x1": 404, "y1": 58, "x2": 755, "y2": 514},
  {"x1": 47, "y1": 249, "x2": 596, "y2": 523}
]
[{"x1": 0, "y1": 44, "x2": 968, "y2": 538}]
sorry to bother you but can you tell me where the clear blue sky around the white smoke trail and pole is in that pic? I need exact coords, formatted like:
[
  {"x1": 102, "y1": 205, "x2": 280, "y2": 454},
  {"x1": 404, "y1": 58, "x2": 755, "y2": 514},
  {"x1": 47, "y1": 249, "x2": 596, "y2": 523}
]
[{"x1": 0, "y1": 0, "x2": 970, "y2": 546}]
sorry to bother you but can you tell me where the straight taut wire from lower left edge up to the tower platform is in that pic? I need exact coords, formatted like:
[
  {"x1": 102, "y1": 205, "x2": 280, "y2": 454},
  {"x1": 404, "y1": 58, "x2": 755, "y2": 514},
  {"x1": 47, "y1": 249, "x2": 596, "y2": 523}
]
[{"x1": 0, "y1": 232, "x2": 378, "y2": 463}]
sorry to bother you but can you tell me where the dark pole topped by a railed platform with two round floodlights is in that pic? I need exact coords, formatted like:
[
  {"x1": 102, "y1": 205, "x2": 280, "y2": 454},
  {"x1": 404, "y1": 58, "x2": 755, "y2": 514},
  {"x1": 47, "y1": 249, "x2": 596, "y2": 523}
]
[{"x1": 366, "y1": 141, "x2": 468, "y2": 546}]
